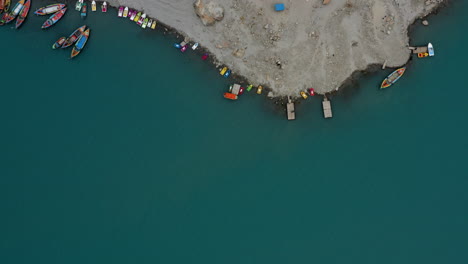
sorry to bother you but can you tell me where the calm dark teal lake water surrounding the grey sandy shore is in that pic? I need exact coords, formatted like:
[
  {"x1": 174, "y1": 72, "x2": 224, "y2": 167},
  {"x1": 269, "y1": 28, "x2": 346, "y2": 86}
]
[{"x1": 0, "y1": 1, "x2": 468, "y2": 264}]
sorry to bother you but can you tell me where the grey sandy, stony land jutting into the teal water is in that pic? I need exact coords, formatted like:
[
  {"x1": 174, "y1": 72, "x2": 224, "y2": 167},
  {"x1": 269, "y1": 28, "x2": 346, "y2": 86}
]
[{"x1": 109, "y1": 0, "x2": 443, "y2": 96}]
